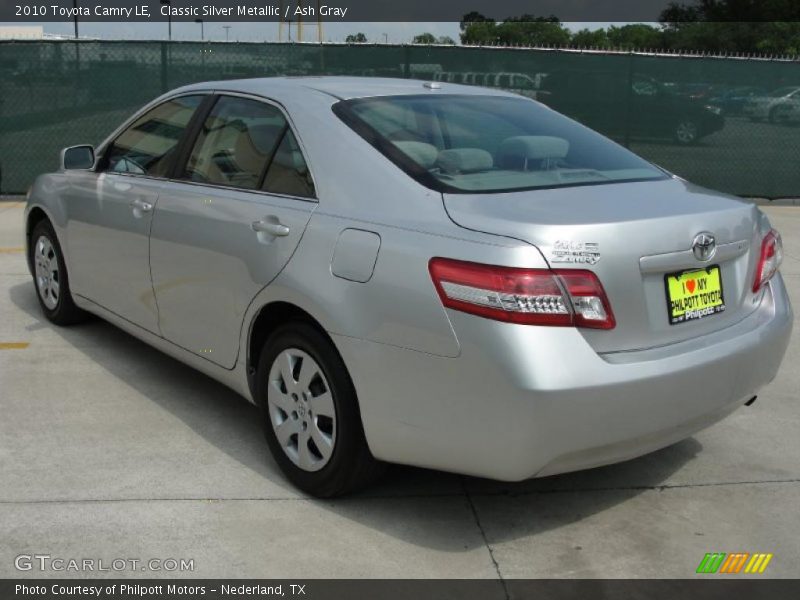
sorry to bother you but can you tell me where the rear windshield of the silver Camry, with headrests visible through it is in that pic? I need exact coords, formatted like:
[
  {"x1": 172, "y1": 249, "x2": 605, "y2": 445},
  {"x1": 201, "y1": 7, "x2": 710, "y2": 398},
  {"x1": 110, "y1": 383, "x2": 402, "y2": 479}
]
[{"x1": 334, "y1": 94, "x2": 666, "y2": 193}]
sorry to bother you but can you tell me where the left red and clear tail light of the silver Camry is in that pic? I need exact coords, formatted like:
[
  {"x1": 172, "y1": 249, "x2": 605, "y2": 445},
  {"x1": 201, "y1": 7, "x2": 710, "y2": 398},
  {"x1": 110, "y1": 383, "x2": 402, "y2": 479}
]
[{"x1": 428, "y1": 258, "x2": 616, "y2": 329}]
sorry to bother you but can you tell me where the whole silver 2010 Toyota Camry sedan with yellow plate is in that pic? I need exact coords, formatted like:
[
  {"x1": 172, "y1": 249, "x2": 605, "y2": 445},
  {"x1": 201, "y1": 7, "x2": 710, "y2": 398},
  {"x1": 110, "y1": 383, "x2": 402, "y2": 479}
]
[{"x1": 25, "y1": 77, "x2": 792, "y2": 496}]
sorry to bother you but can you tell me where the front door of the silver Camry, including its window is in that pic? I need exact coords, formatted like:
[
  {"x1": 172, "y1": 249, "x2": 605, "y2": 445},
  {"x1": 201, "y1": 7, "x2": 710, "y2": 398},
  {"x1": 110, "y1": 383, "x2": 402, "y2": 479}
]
[{"x1": 66, "y1": 94, "x2": 205, "y2": 333}]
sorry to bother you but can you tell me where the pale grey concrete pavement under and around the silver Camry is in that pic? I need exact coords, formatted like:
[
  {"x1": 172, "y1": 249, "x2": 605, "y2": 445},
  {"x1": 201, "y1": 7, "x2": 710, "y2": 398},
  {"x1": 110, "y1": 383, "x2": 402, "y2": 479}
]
[{"x1": 0, "y1": 202, "x2": 800, "y2": 578}]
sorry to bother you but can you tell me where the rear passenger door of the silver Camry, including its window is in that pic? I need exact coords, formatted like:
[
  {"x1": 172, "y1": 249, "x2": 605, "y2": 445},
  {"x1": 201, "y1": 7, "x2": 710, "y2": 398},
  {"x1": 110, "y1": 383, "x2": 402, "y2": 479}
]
[{"x1": 150, "y1": 95, "x2": 316, "y2": 368}]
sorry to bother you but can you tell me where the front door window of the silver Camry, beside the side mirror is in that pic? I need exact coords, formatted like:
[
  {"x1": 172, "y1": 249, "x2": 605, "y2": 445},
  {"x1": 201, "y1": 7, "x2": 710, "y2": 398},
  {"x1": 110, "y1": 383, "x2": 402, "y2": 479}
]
[{"x1": 106, "y1": 96, "x2": 204, "y2": 177}]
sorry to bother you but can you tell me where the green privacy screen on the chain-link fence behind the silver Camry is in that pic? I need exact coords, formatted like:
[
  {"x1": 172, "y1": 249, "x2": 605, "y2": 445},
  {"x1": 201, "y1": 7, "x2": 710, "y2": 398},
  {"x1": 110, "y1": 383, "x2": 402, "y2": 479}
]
[{"x1": 0, "y1": 41, "x2": 800, "y2": 198}]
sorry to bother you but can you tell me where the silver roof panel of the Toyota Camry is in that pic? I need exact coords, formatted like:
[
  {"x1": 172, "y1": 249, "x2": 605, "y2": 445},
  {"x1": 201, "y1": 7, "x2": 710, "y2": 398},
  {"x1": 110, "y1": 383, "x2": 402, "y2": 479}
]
[{"x1": 175, "y1": 76, "x2": 518, "y2": 100}]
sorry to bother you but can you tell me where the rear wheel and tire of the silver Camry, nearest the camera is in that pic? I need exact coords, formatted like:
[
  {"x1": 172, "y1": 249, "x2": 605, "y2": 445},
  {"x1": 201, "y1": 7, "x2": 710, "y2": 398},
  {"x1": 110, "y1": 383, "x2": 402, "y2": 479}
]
[{"x1": 256, "y1": 321, "x2": 382, "y2": 498}]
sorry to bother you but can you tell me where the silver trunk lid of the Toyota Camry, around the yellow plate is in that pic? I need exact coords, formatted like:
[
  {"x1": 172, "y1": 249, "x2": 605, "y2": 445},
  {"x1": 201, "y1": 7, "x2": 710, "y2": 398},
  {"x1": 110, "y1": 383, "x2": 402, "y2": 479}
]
[{"x1": 443, "y1": 178, "x2": 761, "y2": 353}]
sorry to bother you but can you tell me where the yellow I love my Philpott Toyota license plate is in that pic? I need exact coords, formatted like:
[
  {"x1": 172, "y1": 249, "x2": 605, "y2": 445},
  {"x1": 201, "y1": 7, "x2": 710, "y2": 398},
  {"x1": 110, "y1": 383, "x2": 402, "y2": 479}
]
[{"x1": 664, "y1": 265, "x2": 725, "y2": 325}]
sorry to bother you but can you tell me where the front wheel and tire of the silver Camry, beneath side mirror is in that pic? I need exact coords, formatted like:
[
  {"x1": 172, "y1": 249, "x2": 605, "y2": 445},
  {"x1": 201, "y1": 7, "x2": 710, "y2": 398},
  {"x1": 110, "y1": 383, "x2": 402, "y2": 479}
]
[{"x1": 28, "y1": 220, "x2": 88, "y2": 326}]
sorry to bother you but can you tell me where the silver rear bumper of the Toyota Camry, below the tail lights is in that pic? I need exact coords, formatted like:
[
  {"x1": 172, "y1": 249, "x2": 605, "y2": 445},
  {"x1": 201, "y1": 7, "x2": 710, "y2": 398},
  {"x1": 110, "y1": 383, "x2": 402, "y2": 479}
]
[{"x1": 333, "y1": 276, "x2": 792, "y2": 481}]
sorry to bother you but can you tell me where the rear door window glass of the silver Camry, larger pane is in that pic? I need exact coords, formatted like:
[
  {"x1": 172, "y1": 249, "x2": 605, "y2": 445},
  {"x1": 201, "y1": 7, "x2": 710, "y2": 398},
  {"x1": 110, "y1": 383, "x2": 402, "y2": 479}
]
[{"x1": 184, "y1": 96, "x2": 286, "y2": 190}]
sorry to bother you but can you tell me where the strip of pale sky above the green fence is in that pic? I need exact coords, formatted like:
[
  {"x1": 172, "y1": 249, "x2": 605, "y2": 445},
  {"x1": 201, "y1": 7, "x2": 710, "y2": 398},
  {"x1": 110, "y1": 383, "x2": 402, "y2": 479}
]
[{"x1": 0, "y1": 22, "x2": 623, "y2": 44}]
